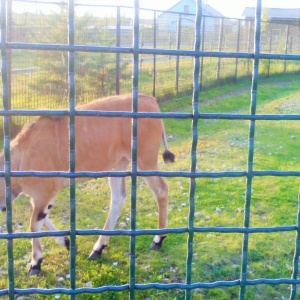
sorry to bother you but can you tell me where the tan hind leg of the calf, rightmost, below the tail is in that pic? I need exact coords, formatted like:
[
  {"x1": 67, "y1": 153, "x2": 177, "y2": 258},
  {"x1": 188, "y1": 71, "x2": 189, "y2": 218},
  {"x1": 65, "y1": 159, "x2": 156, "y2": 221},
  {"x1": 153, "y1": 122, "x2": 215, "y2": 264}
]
[{"x1": 145, "y1": 176, "x2": 169, "y2": 250}]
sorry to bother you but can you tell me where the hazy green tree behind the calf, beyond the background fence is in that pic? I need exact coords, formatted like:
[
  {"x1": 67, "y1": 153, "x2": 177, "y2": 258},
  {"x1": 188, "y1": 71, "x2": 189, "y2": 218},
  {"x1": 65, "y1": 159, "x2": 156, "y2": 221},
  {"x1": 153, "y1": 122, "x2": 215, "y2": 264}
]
[{"x1": 31, "y1": 9, "x2": 128, "y2": 106}]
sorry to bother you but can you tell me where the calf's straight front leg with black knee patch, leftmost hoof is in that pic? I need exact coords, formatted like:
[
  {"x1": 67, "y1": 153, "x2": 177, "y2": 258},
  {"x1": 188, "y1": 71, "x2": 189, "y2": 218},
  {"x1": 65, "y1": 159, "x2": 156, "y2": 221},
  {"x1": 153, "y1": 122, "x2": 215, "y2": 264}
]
[{"x1": 28, "y1": 201, "x2": 48, "y2": 275}]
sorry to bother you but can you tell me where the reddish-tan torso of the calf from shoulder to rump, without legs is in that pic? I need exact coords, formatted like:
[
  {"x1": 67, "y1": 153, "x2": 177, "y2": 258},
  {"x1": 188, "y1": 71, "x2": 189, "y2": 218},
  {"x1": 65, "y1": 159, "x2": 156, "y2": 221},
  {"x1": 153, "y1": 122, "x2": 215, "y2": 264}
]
[{"x1": 15, "y1": 94, "x2": 162, "y2": 171}]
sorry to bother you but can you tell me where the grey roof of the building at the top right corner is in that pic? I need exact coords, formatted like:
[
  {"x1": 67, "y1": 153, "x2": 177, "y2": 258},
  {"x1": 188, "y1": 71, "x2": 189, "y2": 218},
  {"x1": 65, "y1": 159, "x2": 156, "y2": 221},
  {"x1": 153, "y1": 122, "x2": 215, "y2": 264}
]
[{"x1": 242, "y1": 7, "x2": 300, "y2": 20}]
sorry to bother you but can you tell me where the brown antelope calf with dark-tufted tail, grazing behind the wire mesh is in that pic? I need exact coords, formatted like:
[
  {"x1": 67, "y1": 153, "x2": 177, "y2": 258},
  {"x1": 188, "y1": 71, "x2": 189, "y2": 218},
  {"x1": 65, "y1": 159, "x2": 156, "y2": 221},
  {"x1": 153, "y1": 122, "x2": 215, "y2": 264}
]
[{"x1": 0, "y1": 94, "x2": 174, "y2": 275}]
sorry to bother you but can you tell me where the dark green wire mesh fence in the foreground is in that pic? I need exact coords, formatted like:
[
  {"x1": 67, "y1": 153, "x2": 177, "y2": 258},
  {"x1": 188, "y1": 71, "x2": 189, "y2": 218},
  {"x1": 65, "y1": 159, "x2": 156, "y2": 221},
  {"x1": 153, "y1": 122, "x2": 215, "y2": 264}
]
[{"x1": 0, "y1": 0, "x2": 300, "y2": 299}]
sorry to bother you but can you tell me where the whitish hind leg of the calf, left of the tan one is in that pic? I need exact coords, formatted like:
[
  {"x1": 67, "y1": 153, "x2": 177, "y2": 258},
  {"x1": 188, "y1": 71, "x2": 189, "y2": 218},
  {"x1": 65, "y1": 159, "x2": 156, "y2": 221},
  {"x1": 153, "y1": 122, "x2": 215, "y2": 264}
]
[{"x1": 89, "y1": 158, "x2": 129, "y2": 260}]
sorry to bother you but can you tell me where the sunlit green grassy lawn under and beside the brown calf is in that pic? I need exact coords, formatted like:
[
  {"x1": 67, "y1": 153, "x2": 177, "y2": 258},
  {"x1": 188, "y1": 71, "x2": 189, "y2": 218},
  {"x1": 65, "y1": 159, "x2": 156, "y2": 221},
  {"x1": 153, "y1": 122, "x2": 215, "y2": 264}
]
[{"x1": 0, "y1": 75, "x2": 300, "y2": 300}]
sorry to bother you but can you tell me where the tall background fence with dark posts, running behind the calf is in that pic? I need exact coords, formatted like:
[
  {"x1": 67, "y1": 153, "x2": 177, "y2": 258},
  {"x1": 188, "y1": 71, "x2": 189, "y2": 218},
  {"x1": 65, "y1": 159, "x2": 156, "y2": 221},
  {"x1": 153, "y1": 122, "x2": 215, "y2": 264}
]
[{"x1": 1, "y1": 0, "x2": 300, "y2": 123}]
